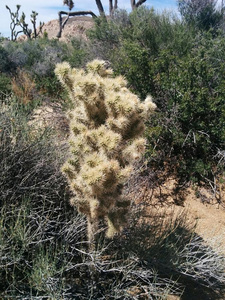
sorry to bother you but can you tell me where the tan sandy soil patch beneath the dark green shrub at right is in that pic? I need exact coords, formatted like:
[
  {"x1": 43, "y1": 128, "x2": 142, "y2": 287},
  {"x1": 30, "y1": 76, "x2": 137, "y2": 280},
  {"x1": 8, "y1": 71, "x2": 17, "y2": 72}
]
[{"x1": 133, "y1": 178, "x2": 225, "y2": 255}]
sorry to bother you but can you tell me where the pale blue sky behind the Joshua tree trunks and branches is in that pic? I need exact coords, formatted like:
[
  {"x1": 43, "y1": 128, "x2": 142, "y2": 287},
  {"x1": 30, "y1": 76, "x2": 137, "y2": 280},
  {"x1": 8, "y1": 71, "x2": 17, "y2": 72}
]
[{"x1": 0, "y1": 0, "x2": 177, "y2": 37}]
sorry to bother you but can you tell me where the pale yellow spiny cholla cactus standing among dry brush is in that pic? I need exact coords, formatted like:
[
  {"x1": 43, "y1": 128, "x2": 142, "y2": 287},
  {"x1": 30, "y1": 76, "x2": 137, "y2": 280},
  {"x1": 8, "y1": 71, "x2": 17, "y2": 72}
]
[{"x1": 55, "y1": 60, "x2": 155, "y2": 241}]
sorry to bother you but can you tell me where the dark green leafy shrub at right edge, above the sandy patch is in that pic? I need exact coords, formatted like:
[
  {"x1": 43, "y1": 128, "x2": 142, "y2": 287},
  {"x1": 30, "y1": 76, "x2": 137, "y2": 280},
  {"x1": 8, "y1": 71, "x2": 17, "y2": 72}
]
[{"x1": 149, "y1": 33, "x2": 225, "y2": 180}]
